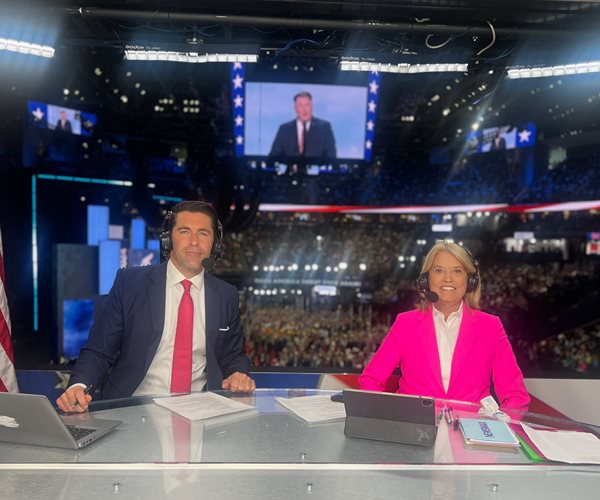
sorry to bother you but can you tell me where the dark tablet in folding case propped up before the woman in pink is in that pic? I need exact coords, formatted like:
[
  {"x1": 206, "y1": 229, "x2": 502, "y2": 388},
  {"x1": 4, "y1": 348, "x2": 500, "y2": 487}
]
[{"x1": 343, "y1": 389, "x2": 437, "y2": 446}]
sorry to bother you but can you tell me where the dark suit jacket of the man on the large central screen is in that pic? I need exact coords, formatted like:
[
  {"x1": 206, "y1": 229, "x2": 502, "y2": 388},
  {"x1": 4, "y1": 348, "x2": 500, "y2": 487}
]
[{"x1": 269, "y1": 117, "x2": 336, "y2": 158}]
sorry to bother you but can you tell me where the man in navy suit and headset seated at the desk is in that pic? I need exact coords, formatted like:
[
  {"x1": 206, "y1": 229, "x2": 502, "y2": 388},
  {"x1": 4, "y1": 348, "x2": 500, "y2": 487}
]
[{"x1": 56, "y1": 201, "x2": 256, "y2": 412}]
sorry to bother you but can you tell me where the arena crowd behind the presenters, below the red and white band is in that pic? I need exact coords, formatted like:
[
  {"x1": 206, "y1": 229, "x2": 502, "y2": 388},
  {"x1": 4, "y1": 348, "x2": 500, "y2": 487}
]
[{"x1": 228, "y1": 214, "x2": 600, "y2": 372}]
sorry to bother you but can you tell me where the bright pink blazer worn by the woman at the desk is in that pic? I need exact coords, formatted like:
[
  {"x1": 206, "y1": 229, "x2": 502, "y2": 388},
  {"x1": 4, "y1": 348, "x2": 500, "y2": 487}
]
[{"x1": 358, "y1": 303, "x2": 530, "y2": 410}]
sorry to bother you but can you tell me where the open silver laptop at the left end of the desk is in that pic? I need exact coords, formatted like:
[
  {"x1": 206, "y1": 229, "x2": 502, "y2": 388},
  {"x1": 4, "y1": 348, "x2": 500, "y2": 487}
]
[{"x1": 0, "y1": 392, "x2": 121, "y2": 450}]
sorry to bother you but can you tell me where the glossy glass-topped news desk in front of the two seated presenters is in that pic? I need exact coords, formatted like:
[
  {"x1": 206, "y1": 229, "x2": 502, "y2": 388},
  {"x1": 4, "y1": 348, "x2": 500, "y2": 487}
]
[{"x1": 0, "y1": 389, "x2": 600, "y2": 500}]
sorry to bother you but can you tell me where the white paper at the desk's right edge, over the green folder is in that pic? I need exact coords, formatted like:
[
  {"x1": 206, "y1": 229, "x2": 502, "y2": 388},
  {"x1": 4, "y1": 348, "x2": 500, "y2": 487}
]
[{"x1": 521, "y1": 422, "x2": 600, "y2": 464}]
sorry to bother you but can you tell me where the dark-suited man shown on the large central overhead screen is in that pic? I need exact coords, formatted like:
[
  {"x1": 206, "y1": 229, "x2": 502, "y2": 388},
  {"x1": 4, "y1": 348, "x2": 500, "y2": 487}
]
[{"x1": 269, "y1": 92, "x2": 336, "y2": 158}]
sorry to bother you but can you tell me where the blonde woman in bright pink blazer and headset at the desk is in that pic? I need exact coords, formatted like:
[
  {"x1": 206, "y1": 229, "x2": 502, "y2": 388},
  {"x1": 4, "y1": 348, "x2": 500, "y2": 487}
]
[{"x1": 359, "y1": 242, "x2": 530, "y2": 410}]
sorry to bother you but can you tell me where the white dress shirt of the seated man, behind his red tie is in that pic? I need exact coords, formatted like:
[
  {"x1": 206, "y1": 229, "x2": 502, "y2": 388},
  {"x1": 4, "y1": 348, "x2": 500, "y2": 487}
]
[{"x1": 133, "y1": 261, "x2": 206, "y2": 396}]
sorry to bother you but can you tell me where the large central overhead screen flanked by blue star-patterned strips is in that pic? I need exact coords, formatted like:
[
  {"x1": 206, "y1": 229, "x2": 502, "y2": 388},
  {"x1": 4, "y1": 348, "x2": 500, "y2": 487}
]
[{"x1": 232, "y1": 65, "x2": 380, "y2": 163}]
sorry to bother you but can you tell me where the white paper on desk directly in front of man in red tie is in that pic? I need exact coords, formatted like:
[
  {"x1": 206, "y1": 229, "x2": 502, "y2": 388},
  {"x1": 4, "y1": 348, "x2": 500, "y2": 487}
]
[{"x1": 154, "y1": 392, "x2": 254, "y2": 420}]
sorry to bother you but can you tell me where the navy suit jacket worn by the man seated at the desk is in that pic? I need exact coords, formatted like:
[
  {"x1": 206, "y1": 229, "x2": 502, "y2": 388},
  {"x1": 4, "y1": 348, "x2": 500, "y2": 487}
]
[{"x1": 69, "y1": 262, "x2": 250, "y2": 399}]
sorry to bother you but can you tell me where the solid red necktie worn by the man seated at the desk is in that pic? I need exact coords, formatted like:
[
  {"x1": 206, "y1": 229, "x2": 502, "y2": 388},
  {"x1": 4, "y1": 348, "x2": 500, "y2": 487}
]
[{"x1": 171, "y1": 280, "x2": 194, "y2": 392}]
